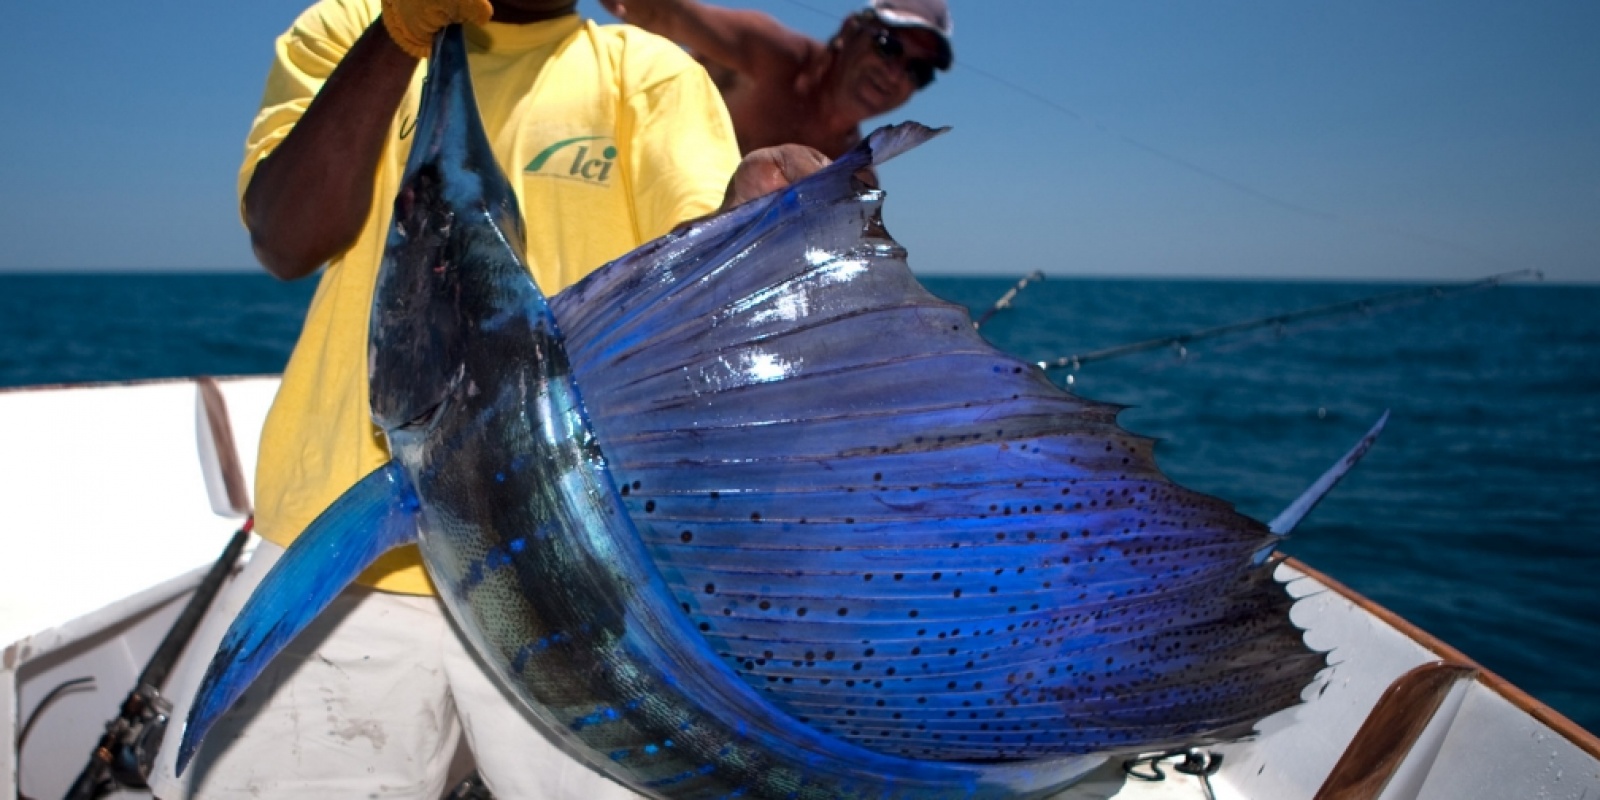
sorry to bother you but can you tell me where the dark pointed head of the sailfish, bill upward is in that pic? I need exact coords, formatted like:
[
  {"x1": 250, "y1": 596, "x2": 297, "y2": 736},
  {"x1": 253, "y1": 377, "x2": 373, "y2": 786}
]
[{"x1": 368, "y1": 26, "x2": 531, "y2": 435}]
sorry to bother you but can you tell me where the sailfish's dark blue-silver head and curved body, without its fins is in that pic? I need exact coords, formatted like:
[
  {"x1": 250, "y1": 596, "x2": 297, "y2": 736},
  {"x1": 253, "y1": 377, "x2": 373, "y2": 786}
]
[{"x1": 370, "y1": 27, "x2": 1102, "y2": 800}]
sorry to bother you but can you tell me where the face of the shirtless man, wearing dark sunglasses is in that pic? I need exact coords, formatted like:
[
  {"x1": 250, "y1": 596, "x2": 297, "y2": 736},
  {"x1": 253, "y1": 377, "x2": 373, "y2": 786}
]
[{"x1": 840, "y1": 19, "x2": 939, "y2": 120}]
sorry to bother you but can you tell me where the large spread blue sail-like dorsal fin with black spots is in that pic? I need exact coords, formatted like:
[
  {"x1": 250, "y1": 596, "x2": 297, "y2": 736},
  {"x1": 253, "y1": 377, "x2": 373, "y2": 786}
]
[{"x1": 552, "y1": 123, "x2": 1325, "y2": 762}]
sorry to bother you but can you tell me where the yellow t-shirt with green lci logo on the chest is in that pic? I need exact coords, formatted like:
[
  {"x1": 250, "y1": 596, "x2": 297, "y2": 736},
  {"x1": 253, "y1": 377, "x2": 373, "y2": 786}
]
[{"x1": 238, "y1": 0, "x2": 739, "y2": 594}]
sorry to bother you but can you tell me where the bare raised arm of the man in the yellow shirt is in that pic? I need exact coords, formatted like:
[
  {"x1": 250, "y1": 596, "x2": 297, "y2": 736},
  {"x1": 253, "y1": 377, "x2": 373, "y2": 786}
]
[{"x1": 243, "y1": 22, "x2": 416, "y2": 280}]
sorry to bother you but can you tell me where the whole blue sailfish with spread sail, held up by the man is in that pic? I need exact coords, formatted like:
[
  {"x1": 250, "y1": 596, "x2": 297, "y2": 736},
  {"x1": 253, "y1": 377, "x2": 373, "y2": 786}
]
[{"x1": 179, "y1": 29, "x2": 1325, "y2": 800}]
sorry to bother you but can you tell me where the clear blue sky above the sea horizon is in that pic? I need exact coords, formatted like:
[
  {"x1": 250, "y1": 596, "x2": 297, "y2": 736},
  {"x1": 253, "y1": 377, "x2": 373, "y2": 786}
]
[{"x1": 0, "y1": 0, "x2": 1600, "y2": 282}]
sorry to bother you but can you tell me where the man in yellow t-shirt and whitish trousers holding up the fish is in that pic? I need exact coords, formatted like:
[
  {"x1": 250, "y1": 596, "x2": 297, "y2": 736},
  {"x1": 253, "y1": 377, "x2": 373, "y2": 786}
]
[{"x1": 152, "y1": 0, "x2": 826, "y2": 800}]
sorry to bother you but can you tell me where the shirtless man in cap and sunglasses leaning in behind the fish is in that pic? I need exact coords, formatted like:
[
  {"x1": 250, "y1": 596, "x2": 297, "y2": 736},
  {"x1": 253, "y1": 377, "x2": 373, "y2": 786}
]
[{"x1": 600, "y1": 0, "x2": 954, "y2": 158}]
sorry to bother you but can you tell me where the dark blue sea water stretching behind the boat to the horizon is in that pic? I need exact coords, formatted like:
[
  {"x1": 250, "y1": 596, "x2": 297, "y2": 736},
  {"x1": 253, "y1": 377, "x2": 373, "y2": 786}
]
[{"x1": 0, "y1": 275, "x2": 1600, "y2": 731}]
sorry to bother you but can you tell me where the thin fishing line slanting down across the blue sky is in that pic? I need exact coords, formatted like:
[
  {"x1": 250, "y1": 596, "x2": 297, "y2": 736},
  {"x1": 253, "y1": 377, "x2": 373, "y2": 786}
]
[{"x1": 768, "y1": 0, "x2": 1509, "y2": 267}]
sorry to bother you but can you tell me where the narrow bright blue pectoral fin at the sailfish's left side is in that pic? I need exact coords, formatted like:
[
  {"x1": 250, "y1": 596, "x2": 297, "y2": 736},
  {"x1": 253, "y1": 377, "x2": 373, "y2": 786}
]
[{"x1": 178, "y1": 461, "x2": 418, "y2": 774}]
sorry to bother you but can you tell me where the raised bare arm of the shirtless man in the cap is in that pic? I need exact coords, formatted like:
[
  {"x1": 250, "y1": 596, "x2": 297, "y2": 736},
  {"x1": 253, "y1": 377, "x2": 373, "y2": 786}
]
[{"x1": 600, "y1": 0, "x2": 811, "y2": 75}]
